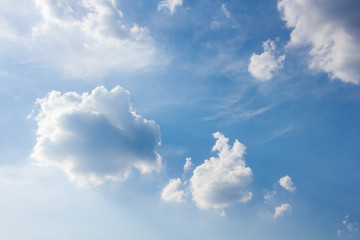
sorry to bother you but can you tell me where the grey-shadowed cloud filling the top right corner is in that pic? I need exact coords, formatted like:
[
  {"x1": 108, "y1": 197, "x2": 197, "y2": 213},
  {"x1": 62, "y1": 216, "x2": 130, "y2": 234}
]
[{"x1": 278, "y1": 0, "x2": 360, "y2": 83}]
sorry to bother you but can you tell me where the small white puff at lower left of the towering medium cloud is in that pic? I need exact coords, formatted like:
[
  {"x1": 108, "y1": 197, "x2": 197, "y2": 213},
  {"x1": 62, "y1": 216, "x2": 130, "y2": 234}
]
[{"x1": 161, "y1": 178, "x2": 185, "y2": 203}]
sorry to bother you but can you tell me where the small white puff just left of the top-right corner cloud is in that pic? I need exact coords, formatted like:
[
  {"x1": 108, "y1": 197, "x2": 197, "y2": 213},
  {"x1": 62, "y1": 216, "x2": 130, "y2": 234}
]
[{"x1": 248, "y1": 39, "x2": 285, "y2": 81}]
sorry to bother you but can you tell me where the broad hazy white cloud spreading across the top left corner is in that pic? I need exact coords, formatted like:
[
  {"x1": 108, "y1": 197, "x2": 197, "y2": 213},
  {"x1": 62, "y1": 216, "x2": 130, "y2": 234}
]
[{"x1": 0, "y1": 0, "x2": 160, "y2": 78}]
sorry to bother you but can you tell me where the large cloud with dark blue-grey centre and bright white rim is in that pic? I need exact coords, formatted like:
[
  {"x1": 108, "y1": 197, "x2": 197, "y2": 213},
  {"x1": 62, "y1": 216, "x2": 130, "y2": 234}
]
[{"x1": 31, "y1": 86, "x2": 161, "y2": 186}]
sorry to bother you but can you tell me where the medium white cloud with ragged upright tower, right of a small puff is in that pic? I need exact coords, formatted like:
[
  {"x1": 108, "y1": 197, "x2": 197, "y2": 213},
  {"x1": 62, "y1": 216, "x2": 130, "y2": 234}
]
[{"x1": 190, "y1": 132, "x2": 252, "y2": 210}]
